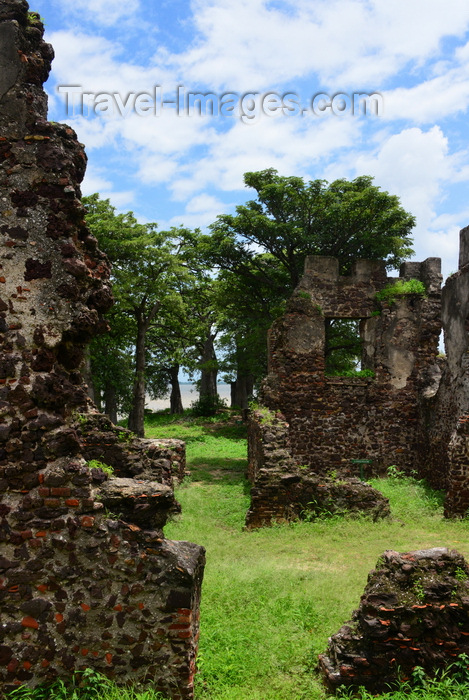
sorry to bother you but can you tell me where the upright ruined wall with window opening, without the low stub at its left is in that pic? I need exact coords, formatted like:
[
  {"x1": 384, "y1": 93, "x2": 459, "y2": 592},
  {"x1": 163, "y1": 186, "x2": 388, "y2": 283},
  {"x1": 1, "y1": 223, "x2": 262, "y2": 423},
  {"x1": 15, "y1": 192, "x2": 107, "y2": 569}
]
[{"x1": 262, "y1": 257, "x2": 441, "y2": 473}]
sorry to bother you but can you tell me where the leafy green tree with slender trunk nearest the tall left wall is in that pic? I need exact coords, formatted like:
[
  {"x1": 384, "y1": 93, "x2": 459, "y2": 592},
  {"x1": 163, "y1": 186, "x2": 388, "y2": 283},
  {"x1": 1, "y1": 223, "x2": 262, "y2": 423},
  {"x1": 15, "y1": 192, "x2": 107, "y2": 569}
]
[{"x1": 84, "y1": 194, "x2": 184, "y2": 435}]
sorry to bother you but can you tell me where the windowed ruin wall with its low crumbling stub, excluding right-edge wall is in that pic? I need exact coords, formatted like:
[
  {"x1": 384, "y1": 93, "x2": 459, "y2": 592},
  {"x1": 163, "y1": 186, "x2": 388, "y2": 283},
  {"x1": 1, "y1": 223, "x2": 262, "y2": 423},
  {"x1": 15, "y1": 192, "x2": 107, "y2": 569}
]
[{"x1": 247, "y1": 257, "x2": 441, "y2": 525}]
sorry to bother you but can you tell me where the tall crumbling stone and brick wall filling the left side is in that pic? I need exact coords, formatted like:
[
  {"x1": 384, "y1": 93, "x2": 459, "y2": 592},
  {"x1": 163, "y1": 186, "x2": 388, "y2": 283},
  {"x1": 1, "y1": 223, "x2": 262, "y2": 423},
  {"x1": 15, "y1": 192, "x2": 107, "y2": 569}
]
[{"x1": 0, "y1": 0, "x2": 204, "y2": 700}]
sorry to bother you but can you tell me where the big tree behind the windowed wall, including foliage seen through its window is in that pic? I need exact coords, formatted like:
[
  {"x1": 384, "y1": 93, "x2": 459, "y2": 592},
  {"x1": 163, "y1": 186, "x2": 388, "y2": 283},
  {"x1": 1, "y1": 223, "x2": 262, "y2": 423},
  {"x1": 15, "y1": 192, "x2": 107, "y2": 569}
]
[{"x1": 199, "y1": 169, "x2": 415, "y2": 400}]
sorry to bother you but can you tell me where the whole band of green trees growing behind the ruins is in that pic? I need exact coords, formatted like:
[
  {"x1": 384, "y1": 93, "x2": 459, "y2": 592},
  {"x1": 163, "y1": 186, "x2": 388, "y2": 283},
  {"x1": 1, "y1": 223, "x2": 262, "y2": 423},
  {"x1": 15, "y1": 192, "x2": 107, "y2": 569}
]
[{"x1": 83, "y1": 168, "x2": 415, "y2": 424}]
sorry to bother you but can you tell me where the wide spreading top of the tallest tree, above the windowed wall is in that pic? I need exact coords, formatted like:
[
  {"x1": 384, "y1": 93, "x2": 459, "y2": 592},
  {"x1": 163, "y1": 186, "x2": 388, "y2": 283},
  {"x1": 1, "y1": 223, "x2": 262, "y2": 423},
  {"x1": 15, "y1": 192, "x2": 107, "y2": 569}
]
[{"x1": 205, "y1": 168, "x2": 415, "y2": 290}]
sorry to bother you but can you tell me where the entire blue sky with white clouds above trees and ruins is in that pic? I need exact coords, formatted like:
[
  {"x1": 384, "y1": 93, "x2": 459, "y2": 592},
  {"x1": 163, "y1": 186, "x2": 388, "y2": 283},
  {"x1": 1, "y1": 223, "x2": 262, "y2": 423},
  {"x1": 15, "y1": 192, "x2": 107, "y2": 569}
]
[{"x1": 31, "y1": 0, "x2": 469, "y2": 274}]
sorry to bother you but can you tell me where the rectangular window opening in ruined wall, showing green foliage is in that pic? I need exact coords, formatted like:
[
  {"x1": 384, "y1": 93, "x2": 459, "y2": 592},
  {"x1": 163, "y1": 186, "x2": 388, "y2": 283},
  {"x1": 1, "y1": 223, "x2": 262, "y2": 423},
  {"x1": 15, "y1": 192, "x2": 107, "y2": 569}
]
[{"x1": 324, "y1": 318, "x2": 371, "y2": 377}]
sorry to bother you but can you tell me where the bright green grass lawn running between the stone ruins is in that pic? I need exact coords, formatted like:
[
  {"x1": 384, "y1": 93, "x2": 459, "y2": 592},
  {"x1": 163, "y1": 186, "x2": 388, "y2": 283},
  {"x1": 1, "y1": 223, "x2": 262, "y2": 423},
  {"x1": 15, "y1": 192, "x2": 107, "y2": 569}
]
[{"x1": 13, "y1": 413, "x2": 469, "y2": 700}]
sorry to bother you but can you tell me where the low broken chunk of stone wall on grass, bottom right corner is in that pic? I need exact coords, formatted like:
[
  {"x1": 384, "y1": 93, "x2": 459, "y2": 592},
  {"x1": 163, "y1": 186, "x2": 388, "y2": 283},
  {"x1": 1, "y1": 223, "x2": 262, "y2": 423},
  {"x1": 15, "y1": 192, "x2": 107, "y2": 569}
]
[{"x1": 319, "y1": 548, "x2": 469, "y2": 693}]
